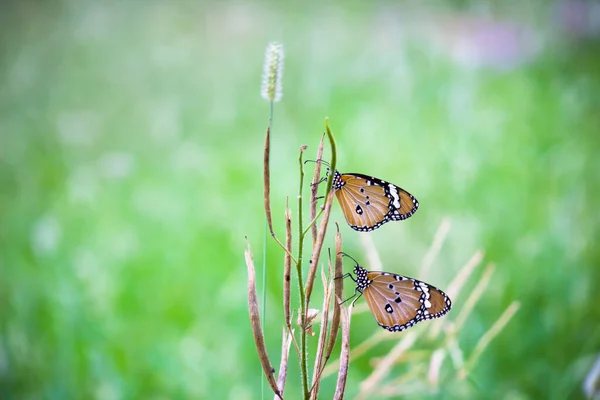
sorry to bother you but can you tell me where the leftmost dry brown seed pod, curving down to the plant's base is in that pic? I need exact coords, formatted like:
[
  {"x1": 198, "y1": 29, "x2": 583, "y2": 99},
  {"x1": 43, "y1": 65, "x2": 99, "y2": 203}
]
[{"x1": 245, "y1": 245, "x2": 282, "y2": 399}]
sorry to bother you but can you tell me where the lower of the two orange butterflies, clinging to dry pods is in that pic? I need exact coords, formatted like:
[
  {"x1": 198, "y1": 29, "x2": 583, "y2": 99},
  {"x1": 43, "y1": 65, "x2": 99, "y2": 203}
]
[{"x1": 342, "y1": 253, "x2": 452, "y2": 332}]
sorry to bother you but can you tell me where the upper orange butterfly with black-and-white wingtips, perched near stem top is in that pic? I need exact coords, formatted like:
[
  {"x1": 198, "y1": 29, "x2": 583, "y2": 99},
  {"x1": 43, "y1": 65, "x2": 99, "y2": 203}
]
[{"x1": 333, "y1": 170, "x2": 419, "y2": 232}]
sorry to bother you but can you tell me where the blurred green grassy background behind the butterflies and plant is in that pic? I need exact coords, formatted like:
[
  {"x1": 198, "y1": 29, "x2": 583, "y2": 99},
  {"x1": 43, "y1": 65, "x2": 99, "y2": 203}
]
[{"x1": 0, "y1": 0, "x2": 600, "y2": 399}]
